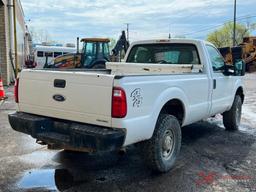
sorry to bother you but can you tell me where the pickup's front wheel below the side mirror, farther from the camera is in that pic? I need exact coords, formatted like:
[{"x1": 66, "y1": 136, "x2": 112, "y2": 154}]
[{"x1": 223, "y1": 95, "x2": 242, "y2": 131}]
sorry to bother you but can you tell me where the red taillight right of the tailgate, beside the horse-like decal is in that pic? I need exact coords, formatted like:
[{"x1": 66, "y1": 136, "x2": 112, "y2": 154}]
[{"x1": 112, "y1": 87, "x2": 127, "y2": 118}]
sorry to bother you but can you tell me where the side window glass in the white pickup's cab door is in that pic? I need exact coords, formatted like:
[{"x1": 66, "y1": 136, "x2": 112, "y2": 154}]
[{"x1": 206, "y1": 45, "x2": 225, "y2": 72}]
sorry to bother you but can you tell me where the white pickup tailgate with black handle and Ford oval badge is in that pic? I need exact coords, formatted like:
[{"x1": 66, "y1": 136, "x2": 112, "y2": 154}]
[{"x1": 19, "y1": 70, "x2": 114, "y2": 126}]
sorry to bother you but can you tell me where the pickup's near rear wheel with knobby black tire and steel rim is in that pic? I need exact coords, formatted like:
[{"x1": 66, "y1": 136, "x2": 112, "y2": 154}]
[{"x1": 142, "y1": 114, "x2": 181, "y2": 173}]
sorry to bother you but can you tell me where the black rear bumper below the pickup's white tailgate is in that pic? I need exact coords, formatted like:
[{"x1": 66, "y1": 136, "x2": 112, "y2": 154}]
[{"x1": 9, "y1": 112, "x2": 126, "y2": 151}]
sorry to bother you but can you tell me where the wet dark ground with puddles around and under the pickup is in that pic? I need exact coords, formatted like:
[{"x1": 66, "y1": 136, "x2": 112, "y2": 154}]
[{"x1": 0, "y1": 73, "x2": 256, "y2": 192}]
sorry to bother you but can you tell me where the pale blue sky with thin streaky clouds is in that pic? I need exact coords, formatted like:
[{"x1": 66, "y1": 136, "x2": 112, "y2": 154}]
[{"x1": 21, "y1": 0, "x2": 256, "y2": 43}]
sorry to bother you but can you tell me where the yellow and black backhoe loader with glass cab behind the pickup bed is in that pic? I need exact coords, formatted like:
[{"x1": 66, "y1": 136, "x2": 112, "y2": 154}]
[{"x1": 44, "y1": 31, "x2": 129, "y2": 69}]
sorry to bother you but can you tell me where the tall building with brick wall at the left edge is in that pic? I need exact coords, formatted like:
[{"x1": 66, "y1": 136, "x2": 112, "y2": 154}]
[{"x1": 0, "y1": 0, "x2": 29, "y2": 85}]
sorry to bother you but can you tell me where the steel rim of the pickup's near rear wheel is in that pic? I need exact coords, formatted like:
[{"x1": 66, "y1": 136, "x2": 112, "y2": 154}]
[{"x1": 162, "y1": 130, "x2": 175, "y2": 160}]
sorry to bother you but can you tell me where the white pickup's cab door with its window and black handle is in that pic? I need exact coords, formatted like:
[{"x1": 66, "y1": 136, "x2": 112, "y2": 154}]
[{"x1": 206, "y1": 45, "x2": 235, "y2": 115}]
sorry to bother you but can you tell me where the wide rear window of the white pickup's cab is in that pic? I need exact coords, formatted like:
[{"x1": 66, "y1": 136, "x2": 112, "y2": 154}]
[{"x1": 127, "y1": 44, "x2": 200, "y2": 64}]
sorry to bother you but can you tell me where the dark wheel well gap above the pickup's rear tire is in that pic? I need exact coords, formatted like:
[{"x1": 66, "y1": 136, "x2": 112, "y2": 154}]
[{"x1": 160, "y1": 99, "x2": 185, "y2": 124}]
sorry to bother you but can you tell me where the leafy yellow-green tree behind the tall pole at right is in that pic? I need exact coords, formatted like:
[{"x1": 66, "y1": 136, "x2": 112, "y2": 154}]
[{"x1": 207, "y1": 22, "x2": 251, "y2": 47}]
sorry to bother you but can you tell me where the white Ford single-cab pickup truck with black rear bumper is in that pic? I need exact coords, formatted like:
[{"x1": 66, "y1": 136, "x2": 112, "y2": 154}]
[{"x1": 9, "y1": 39, "x2": 244, "y2": 172}]
